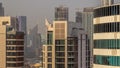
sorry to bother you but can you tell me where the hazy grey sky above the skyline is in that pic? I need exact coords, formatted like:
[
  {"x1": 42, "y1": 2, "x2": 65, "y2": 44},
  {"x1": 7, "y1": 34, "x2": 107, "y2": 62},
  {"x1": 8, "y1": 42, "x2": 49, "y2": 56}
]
[{"x1": 0, "y1": 0, "x2": 100, "y2": 35}]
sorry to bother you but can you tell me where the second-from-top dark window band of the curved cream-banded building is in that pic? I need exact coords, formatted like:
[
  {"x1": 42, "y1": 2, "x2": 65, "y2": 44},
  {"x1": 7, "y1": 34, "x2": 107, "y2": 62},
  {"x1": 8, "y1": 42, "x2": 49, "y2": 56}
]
[{"x1": 94, "y1": 22, "x2": 120, "y2": 33}]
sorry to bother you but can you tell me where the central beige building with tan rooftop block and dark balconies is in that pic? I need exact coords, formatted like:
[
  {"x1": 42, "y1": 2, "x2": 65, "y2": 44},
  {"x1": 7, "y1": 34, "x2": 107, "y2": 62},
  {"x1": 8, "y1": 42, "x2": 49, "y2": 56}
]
[{"x1": 43, "y1": 20, "x2": 80, "y2": 68}]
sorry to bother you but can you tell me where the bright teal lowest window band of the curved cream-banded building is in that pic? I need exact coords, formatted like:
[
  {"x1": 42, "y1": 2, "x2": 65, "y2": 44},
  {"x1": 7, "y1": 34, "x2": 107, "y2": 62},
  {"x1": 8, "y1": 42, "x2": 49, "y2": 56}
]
[{"x1": 94, "y1": 55, "x2": 120, "y2": 66}]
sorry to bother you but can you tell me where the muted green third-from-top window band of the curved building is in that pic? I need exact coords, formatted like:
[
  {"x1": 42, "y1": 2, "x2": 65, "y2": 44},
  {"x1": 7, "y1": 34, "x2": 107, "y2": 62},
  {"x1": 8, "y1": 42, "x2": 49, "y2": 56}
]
[{"x1": 94, "y1": 39, "x2": 120, "y2": 49}]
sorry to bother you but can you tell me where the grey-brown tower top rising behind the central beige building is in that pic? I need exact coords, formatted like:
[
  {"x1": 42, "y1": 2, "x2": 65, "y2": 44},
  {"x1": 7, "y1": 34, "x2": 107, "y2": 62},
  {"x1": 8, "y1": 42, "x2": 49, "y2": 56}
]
[{"x1": 55, "y1": 6, "x2": 69, "y2": 21}]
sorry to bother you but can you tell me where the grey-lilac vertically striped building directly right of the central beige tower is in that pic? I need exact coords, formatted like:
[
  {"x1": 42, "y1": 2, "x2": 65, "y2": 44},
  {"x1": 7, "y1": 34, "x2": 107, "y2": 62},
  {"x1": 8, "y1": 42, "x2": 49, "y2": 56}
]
[{"x1": 78, "y1": 28, "x2": 91, "y2": 68}]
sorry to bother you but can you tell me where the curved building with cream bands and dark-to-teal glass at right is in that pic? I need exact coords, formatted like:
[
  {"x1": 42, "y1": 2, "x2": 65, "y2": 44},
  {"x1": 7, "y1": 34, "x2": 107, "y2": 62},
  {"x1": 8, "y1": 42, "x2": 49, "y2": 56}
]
[{"x1": 93, "y1": 0, "x2": 120, "y2": 68}]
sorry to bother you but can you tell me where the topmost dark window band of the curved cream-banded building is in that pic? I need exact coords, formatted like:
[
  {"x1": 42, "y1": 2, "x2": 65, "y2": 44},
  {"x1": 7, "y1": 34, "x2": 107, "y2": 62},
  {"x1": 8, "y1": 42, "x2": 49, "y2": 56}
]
[{"x1": 94, "y1": 5, "x2": 120, "y2": 17}]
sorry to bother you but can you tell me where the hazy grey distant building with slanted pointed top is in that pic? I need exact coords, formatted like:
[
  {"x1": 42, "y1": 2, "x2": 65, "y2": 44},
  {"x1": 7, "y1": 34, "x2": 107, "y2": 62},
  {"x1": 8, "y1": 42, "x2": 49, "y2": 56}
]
[{"x1": 26, "y1": 25, "x2": 41, "y2": 58}]
